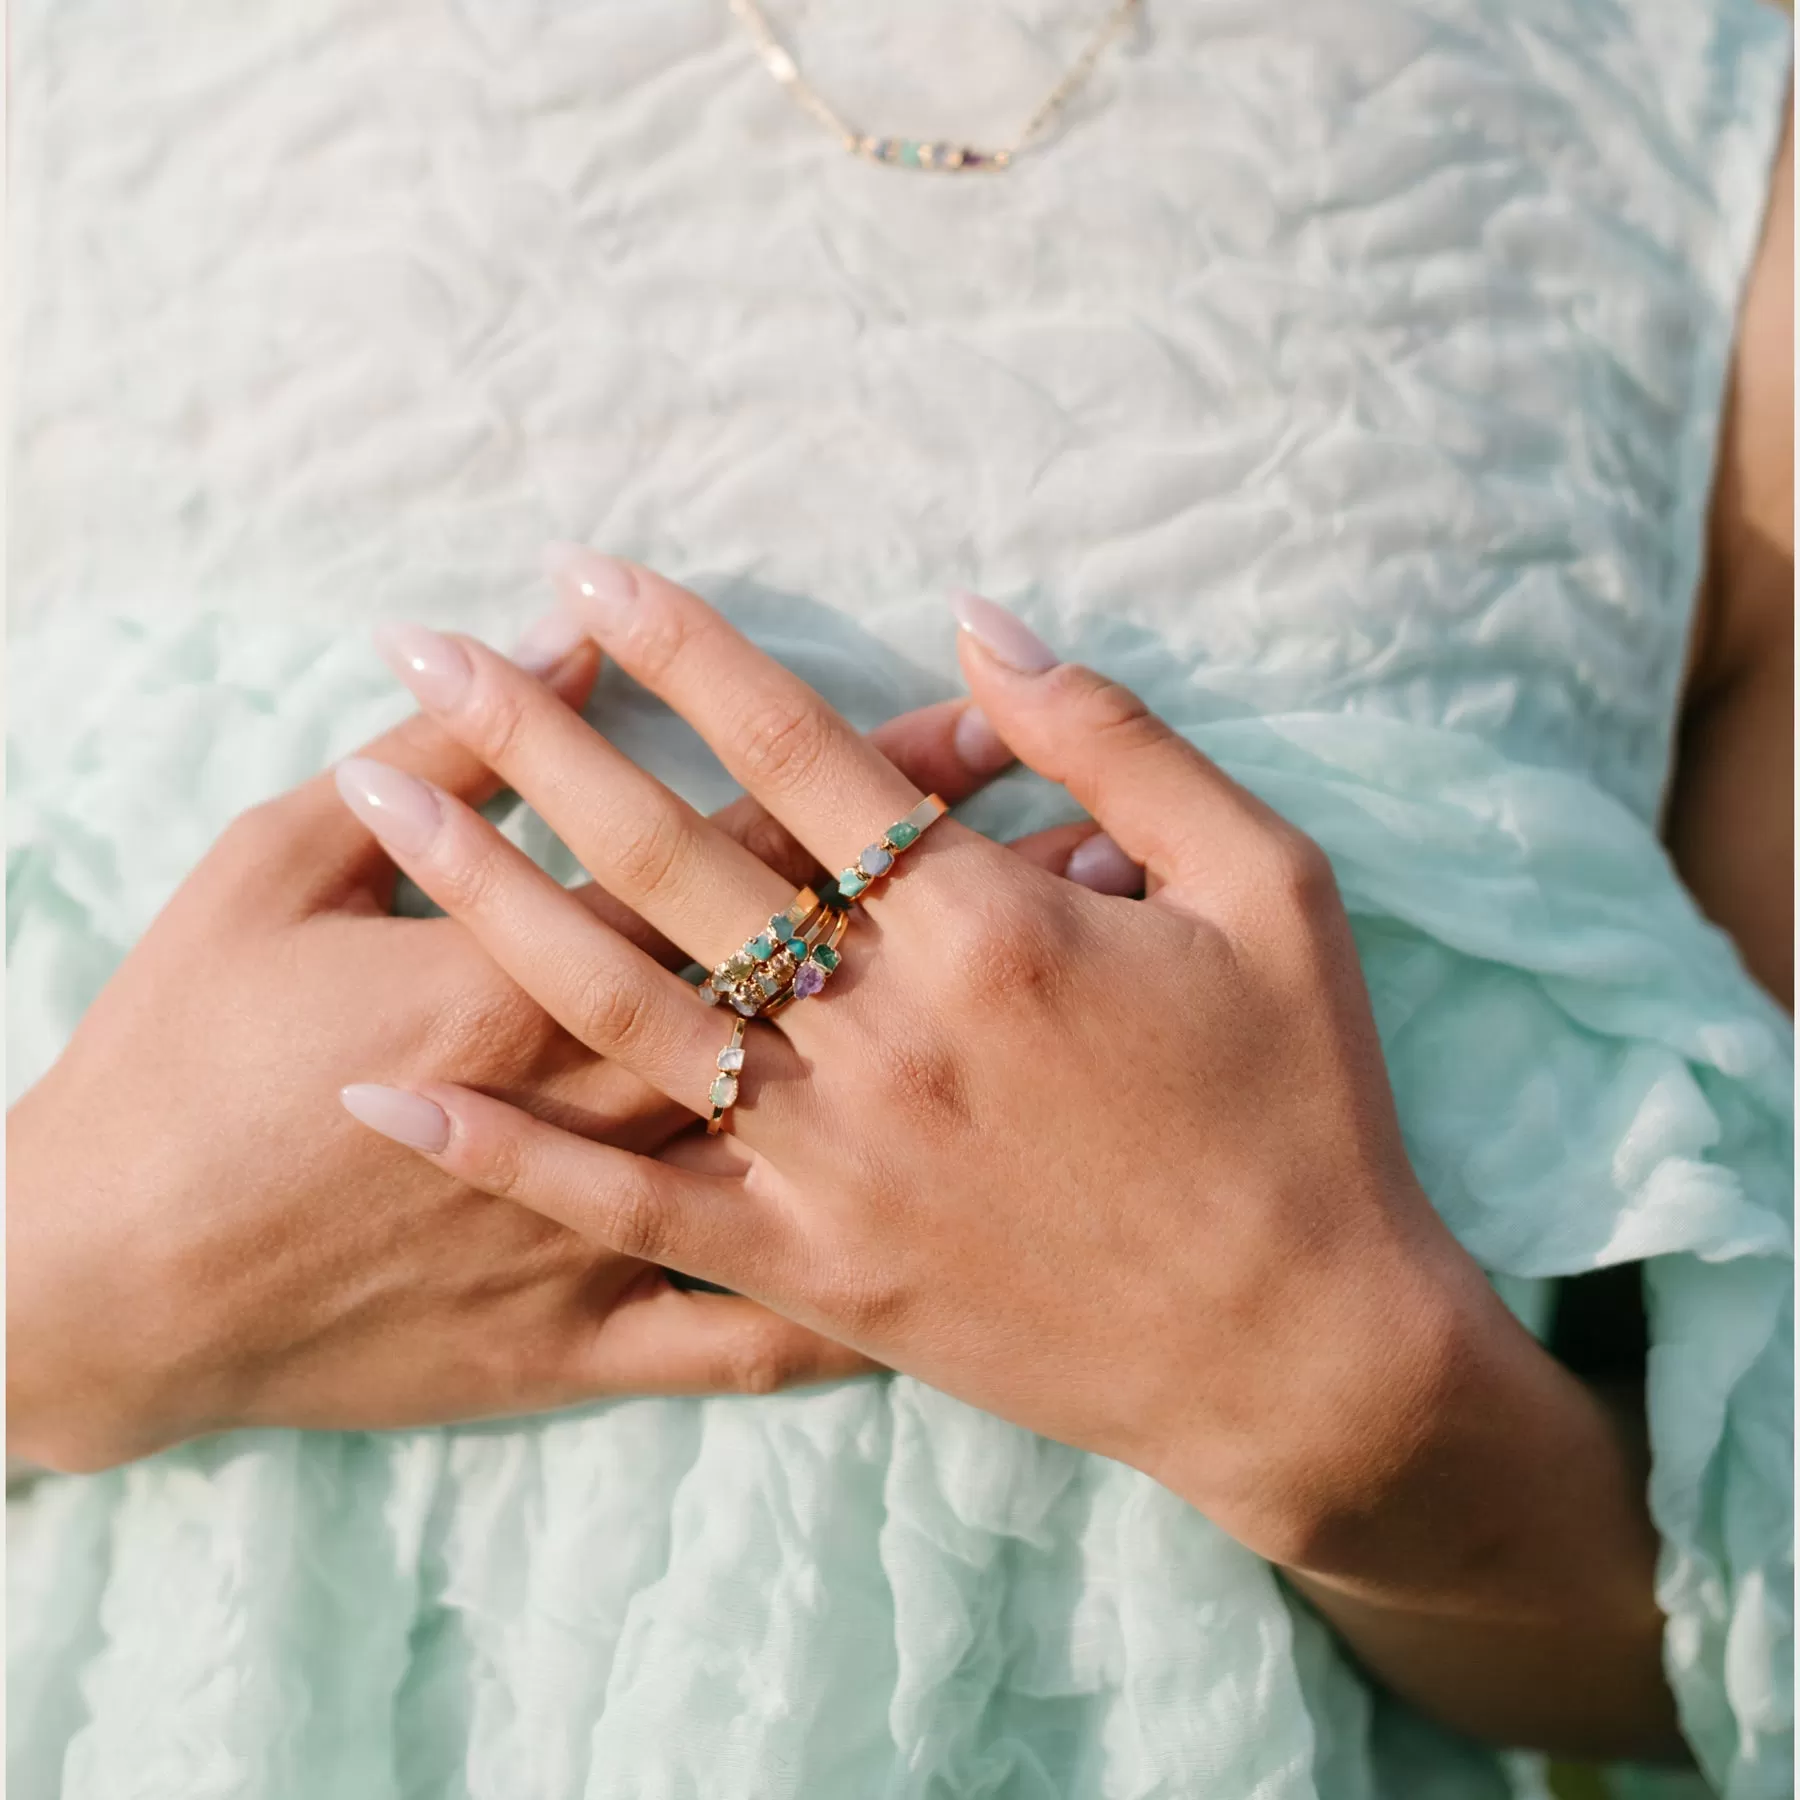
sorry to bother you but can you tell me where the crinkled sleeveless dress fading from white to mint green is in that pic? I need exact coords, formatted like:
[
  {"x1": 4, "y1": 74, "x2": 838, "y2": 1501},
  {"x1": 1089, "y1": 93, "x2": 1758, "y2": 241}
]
[{"x1": 7, "y1": 0, "x2": 1793, "y2": 1800}]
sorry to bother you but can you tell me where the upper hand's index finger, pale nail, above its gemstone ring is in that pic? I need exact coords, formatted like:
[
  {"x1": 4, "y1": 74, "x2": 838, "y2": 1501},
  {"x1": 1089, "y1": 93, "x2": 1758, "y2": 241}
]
[{"x1": 551, "y1": 545, "x2": 941, "y2": 869}]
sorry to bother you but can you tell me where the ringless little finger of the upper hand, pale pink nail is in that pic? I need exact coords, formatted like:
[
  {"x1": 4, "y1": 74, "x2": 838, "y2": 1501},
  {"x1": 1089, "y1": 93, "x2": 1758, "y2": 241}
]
[{"x1": 344, "y1": 1082, "x2": 790, "y2": 1296}]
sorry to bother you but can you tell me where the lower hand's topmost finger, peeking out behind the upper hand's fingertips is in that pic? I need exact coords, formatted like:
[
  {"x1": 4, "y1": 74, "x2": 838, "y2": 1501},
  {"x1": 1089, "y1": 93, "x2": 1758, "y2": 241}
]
[{"x1": 243, "y1": 612, "x2": 599, "y2": 913}]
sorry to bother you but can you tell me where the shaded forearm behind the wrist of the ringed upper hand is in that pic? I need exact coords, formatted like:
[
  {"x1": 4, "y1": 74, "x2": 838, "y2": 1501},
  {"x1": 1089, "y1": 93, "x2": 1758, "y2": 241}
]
[{"x1": 1289, "y1": 1267, "x2": 1685, "y2": 1760}]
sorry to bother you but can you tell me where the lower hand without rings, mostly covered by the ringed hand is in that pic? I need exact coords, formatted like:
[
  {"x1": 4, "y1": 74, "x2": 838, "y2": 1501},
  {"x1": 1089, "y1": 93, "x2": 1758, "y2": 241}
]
[{"x1": 7, "y1": 622, "x2": 1137, "y2": 1471}]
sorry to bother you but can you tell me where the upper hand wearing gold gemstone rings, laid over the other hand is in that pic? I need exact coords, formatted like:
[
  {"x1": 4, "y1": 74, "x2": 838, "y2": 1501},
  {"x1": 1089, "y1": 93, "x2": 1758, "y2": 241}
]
[{"x1": 346, "y1": 553, "x2": 1654, "y2": 1756}]
